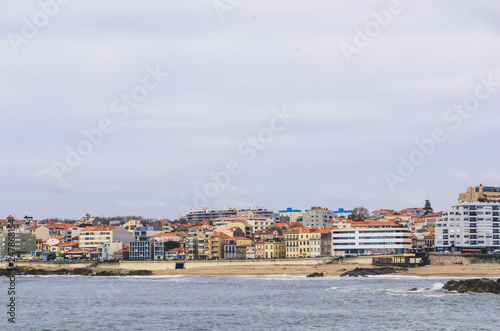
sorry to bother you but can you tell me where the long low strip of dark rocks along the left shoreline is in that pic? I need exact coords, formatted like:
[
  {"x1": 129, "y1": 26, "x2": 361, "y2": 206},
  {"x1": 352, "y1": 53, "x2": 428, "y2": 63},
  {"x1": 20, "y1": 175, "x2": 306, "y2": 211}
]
[{"x1": 0, "y1": 267, "x2": 153, "y2": 276}]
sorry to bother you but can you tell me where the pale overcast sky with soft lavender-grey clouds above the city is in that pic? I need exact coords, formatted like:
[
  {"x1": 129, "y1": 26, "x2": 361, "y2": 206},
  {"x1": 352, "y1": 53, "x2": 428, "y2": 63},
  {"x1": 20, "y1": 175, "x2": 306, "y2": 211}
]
[{"x1": 0, "y1": 0, "x2": 500, "y2": 219}]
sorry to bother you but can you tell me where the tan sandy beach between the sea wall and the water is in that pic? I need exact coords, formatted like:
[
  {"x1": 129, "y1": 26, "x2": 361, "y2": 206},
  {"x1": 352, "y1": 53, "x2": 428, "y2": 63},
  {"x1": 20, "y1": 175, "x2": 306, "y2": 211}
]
[{"x1": 154, "y1": 264, "x2": 500, "y2": 278}]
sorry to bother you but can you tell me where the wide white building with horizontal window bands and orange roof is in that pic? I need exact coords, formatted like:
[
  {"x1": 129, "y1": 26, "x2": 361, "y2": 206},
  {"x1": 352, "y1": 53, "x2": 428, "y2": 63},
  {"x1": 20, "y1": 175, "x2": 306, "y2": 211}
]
[{"x1": 332, "y1": 222, "x2": 412, "y2": 256}]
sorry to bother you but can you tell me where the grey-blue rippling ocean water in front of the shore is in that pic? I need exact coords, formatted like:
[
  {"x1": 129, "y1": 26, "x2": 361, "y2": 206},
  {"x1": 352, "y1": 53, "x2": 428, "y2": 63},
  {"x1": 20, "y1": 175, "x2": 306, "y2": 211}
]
[{"x1": 0, "y1": 275, "x2": 500, "y2": 331}]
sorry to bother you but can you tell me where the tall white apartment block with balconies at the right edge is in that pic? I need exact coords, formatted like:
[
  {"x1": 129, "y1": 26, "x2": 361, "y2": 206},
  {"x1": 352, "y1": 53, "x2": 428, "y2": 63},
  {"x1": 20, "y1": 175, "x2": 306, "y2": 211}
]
[{"x1": 435, "y1": 200, "x2": 500, "y2": 253}]
